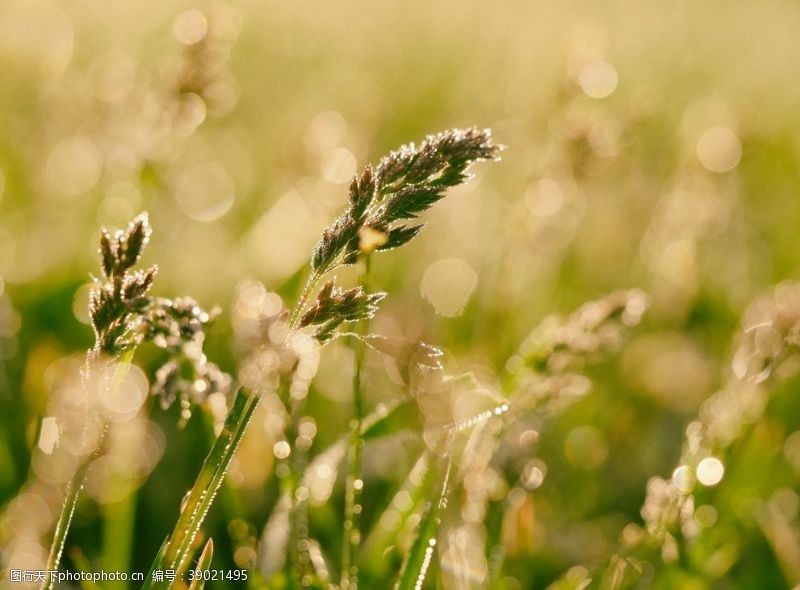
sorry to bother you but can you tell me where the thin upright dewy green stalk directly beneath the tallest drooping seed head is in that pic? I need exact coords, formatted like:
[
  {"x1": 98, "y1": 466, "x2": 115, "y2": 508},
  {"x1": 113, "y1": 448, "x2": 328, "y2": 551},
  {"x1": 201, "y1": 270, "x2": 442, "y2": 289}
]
[{"x1": 340, "y1": 254, "x2": 370, "y2": 590}]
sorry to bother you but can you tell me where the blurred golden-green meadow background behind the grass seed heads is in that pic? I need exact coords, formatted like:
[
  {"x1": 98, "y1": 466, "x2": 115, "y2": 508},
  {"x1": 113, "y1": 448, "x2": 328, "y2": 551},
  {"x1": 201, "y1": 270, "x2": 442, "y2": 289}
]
[{"x1": 0, "y1": 0, "x2": 800, "y2": 589}]
